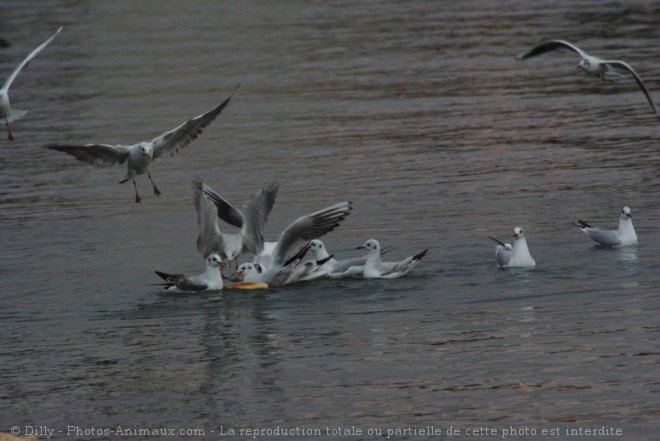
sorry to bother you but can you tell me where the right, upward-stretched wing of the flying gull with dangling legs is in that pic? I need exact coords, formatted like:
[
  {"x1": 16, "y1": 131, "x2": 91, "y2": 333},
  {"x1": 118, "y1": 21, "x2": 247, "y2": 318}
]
[{"x1": 151, "y1": 86, "x2": 233, "y2": 159}]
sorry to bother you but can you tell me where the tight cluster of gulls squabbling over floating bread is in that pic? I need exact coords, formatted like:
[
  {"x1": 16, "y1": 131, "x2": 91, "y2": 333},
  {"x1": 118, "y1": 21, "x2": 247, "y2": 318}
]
[{"x1": 156, "y1": 179, "x2": 428, "y2": 291}]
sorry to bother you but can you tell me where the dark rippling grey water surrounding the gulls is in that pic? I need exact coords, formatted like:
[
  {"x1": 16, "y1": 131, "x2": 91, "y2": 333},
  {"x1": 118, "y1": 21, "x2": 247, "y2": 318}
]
[{"x1": 0, "y1": 0, "x2": 660, "y2": 440}]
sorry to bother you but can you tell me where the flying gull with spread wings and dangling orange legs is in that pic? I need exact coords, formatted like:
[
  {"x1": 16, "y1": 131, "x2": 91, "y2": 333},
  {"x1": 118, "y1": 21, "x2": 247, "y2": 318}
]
[{"x1": 44, "y1": 86, "x2": 238, "y2": 204}]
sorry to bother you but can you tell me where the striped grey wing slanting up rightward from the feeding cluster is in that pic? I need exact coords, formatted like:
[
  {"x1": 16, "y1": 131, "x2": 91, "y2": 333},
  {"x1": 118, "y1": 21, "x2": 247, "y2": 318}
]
[{"x1": 271, "y1": 202, "x2": 353, "y2": 266}]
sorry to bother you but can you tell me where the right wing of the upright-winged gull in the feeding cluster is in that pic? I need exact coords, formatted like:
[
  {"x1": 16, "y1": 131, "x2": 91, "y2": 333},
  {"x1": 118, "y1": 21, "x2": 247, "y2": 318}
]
[{"x1": 240, "y1": 183, "x2": 279, "y2": 256}]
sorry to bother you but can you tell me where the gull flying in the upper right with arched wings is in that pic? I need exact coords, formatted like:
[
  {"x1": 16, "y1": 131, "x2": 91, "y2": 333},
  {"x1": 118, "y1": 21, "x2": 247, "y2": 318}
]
[{"x1": 516, "y1": 40, "x2": 658, "y2": 113}]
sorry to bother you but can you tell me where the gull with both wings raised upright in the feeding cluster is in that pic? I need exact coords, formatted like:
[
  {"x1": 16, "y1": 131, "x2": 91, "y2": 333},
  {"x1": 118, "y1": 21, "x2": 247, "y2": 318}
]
[{"x1": 193, "y1": 179, "x2": 279, "y2": 261}]
